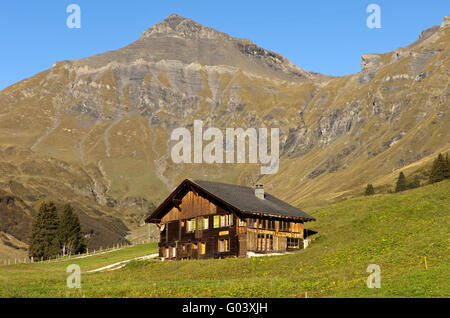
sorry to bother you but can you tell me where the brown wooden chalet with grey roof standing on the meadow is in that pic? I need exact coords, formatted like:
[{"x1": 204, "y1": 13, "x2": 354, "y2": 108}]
[{"x1": 145, "y1": 179, "x2": 315, "y2": 260}]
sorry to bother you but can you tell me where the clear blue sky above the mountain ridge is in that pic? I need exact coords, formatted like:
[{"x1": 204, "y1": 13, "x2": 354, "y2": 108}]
[{"x1": 0, "y1": 0, "x2": 450, "y2": 89}]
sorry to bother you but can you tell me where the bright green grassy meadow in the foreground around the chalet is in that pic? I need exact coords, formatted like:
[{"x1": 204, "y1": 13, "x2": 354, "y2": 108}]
[{"x1": 0, "y1": 181, "x2": 450, "y2": 297}]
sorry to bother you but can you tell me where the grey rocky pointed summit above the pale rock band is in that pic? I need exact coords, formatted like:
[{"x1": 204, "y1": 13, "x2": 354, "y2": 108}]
[{"x1": 102, "y1": 14, "x2": 321, "y2": 81}]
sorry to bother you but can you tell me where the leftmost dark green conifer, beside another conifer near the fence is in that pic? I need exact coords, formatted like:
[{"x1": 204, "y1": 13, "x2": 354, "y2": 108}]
[{"x1": 29, "y1": 201, "x2": 59, "y2": 259}]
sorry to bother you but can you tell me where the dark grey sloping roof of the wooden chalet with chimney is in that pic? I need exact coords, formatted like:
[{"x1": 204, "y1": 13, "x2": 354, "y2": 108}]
[{"x1": 189, "y1": 179, "x2": 316, "y2": 221}]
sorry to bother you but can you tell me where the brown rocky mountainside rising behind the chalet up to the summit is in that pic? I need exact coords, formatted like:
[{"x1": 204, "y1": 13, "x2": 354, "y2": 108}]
[{"x1": 0, "y1": 15, "x2": 450, "y2": 247}]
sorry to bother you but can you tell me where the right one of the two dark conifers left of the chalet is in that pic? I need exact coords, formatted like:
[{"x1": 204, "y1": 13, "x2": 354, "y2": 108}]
[{"x1": 59, "y1": 204, "x2": 86, "y2": 255}]
